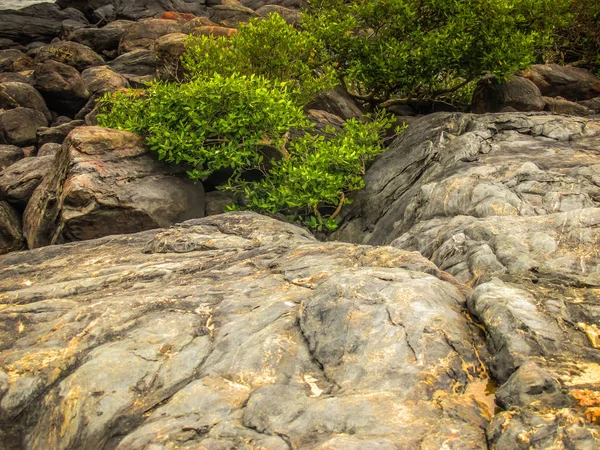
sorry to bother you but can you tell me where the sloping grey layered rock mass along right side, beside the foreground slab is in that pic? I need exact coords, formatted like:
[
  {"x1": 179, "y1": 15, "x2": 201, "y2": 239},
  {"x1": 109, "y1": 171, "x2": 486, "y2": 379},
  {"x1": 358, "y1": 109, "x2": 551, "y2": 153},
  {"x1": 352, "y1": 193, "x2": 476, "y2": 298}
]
[{"x1": 337, "y1": 114, "x2": 600, "y2": 450}]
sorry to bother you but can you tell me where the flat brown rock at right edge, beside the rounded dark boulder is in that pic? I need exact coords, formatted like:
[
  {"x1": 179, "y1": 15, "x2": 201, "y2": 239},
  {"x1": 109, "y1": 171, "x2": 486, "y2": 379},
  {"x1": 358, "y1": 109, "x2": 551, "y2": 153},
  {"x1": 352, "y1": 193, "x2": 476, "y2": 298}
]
[{"x1": 523, "y1": 64, "x2": 600, "y2": 102}]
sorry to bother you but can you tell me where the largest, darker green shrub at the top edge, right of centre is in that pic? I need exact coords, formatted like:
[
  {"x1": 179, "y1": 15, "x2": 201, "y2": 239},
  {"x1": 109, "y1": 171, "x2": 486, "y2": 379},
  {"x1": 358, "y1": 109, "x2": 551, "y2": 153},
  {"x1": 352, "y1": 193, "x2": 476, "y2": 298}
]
[{"x1": 303, "y1": 0, "x2": 570, "y2": 106}]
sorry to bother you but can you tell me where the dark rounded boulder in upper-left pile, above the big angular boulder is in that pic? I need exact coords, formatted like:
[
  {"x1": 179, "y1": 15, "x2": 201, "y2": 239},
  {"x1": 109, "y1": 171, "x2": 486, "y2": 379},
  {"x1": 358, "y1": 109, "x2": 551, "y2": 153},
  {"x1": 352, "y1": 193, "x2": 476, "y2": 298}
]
[{"x1": 34, "y1": 60, "x2": 90, "y2": 115}]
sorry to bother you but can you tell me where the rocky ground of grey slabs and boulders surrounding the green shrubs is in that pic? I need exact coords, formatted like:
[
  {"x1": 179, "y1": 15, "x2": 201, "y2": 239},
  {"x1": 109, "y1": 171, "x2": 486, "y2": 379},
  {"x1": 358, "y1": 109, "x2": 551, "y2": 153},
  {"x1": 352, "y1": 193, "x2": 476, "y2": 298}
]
[{"x1": 0, "y1": 0, "x2": 600, "y2": 450}]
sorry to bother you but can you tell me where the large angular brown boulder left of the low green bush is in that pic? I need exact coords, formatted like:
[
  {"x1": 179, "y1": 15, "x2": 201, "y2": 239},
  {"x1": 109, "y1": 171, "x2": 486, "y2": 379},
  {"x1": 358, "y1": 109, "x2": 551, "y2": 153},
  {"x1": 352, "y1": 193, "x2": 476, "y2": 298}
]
[{"x1": 24, "y1": 127, "x2": 204, "y2": 248}]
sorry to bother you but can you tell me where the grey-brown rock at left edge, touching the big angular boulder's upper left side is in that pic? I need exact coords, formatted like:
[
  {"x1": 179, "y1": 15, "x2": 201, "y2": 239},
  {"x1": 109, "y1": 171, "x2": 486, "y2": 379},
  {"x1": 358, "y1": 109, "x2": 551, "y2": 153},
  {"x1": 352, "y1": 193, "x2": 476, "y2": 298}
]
[{"x1": 0, "y1": 156, "x2": 54, "y2": 207}]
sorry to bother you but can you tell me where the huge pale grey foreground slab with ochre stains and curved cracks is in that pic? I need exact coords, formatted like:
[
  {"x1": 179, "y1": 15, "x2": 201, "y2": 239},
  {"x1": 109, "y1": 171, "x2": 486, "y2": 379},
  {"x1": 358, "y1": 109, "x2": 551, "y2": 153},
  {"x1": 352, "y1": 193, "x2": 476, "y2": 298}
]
[{"x1": 0, "y1": 213, "x2": 489, "y2": 450}]
